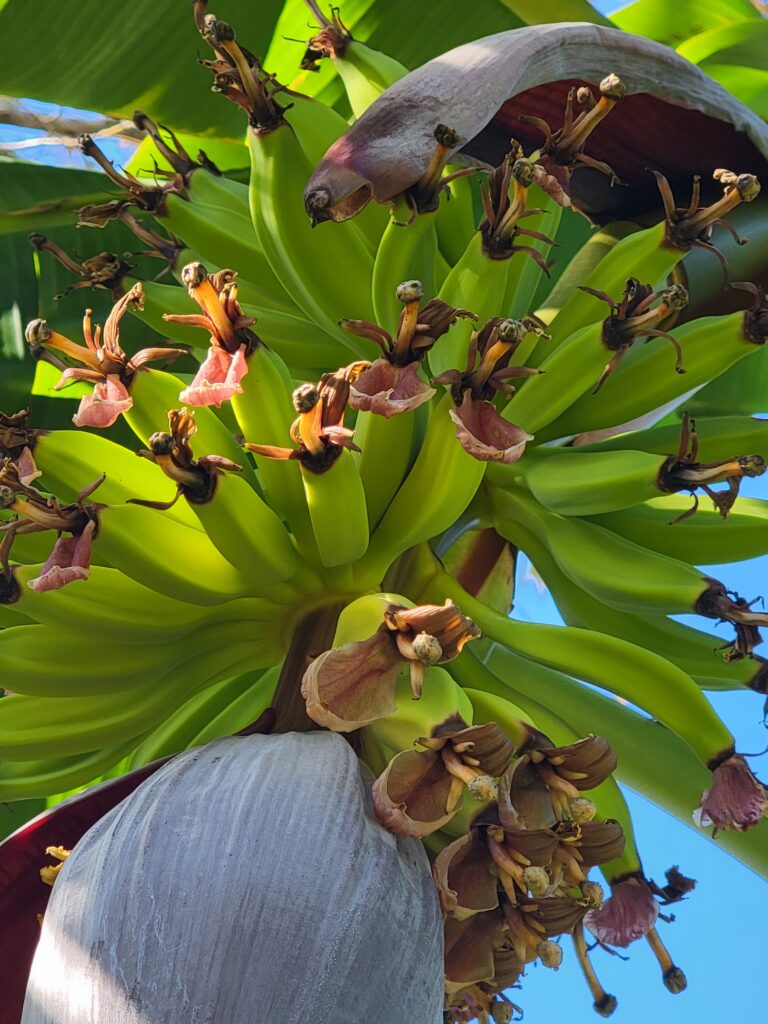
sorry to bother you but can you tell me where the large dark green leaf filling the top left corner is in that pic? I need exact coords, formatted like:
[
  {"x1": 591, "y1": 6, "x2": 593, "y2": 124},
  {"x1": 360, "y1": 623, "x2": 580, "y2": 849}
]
[{"x1": 0, "y1": 0, "x2": 282, "y2": 138}]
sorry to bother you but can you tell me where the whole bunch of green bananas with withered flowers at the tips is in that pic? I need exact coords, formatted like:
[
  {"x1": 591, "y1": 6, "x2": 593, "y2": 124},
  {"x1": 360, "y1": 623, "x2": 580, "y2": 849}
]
[{"x1": 0, "y1": 4, "x2": 768, "y2": 1021}]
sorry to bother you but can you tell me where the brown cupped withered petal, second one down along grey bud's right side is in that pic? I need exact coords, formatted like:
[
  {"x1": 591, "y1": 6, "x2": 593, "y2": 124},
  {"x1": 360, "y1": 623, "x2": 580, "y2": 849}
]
[{"x1": 432, "y1": 829, "x2": 499, "y2": 921}]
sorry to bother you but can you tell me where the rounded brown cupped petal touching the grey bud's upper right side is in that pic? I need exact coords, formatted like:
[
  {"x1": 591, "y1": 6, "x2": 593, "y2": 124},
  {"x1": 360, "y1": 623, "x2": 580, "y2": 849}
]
[{"x1": 373, "y1": 751, "x2": 461, "y2": 839}]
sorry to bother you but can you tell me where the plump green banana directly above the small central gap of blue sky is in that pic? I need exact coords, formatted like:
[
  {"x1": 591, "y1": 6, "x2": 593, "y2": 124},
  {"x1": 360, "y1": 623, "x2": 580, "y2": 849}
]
[{"x1": 489, "y1": 488, "x2": 729, "y2": 614}]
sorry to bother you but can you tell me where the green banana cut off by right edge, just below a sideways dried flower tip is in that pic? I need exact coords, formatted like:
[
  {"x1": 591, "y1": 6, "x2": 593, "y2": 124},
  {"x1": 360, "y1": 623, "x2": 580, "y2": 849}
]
[{"x1": 589, "y1": 495, "x2": 768, "y2": 565}]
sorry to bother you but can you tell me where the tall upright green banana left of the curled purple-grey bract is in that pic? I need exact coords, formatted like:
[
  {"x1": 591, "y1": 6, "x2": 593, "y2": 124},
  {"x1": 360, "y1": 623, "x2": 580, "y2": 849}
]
[{"x1": 248, "y1": 116, "x2": 373, "y2": 354}]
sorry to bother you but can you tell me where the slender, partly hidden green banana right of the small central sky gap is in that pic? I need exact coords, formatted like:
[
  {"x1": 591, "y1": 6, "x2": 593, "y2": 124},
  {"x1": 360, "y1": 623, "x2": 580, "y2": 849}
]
[{"x1": 493, "y1": 523, "x2": 766, "y2": 692}]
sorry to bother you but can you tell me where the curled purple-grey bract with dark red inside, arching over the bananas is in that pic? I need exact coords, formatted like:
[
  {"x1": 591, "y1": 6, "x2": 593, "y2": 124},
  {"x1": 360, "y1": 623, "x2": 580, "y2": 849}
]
[{"x1": 304, "y1": 23, "x2": 768, "y2": 220}]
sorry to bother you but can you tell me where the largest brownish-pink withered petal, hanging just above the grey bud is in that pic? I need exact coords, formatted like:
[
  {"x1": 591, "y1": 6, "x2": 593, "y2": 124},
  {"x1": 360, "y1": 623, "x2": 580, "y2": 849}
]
[{"x1": 301, "y1": 630, "x2": 404, "y2": 732}]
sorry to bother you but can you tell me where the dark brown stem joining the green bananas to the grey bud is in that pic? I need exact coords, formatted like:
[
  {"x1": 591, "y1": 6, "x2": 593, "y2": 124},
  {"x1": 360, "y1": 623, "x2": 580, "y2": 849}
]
[{"x1": 272, "y1": 601, "x2": 345, "y2": 732}]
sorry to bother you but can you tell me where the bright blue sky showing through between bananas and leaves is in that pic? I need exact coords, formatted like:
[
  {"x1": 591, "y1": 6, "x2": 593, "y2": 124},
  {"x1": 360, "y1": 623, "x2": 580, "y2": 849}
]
[{"x1": 0, "y1": 0, "x2": 768, "y2": 1024}]
